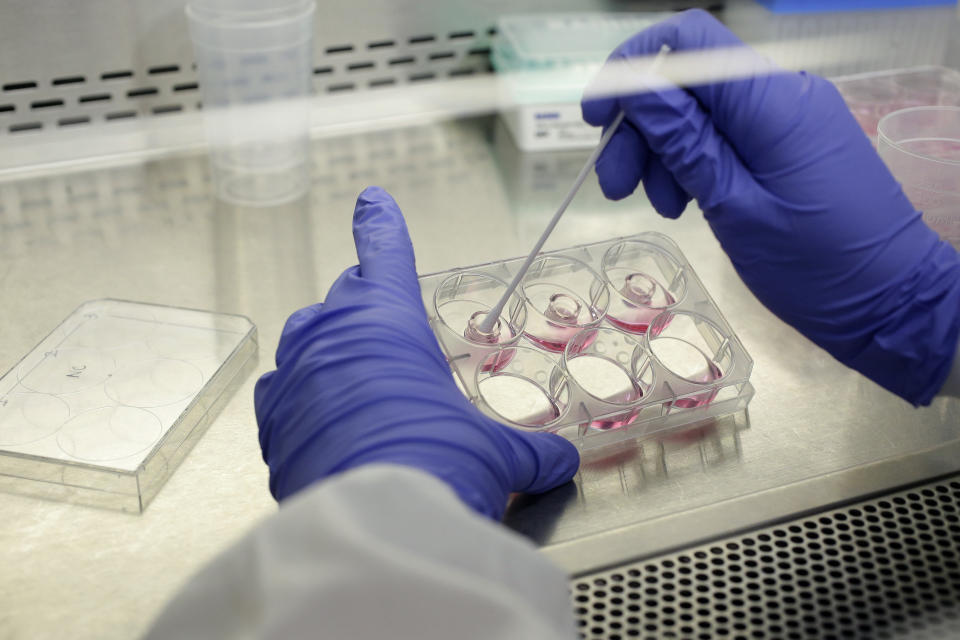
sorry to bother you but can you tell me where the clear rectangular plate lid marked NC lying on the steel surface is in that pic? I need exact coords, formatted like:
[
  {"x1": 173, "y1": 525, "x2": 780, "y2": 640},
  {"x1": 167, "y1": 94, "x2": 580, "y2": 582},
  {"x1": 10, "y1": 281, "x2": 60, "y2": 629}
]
[{"x1": 0, "y1": 300, "x2": 257, "y2": 513}]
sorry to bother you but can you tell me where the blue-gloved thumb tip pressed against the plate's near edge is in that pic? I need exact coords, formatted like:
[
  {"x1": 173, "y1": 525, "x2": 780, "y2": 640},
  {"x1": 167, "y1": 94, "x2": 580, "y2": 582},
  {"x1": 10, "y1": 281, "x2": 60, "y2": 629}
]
[{"x1": 504, "y1": 427, "x2": 580, "y2": 493}]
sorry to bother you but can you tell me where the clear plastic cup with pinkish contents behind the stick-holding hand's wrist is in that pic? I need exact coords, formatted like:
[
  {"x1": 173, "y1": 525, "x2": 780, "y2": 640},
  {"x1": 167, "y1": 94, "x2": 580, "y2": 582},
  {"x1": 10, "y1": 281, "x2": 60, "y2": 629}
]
[{"x1": 877, "y1": 107, "x2": 960, "y2": 248}]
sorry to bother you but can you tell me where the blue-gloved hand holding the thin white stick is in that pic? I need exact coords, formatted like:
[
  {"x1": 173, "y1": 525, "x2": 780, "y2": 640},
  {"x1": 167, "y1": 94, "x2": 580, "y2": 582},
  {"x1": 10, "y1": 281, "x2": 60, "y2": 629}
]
[{"x1": 582, "y1": 11, "x2": 960, "y2": 405}]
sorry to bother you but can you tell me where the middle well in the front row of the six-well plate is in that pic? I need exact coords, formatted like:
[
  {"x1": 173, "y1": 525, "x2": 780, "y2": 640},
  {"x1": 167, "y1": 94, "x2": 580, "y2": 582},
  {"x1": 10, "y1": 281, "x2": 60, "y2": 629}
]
[{"x1": 562, "y1": 327, "x2": 654, "y2": 430}]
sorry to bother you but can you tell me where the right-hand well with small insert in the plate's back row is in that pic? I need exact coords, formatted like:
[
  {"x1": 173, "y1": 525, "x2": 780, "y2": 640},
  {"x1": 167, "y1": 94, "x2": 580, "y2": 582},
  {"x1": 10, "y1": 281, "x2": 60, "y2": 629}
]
[{"x1": 600, "y1": 240, "x2": 687, "y2": 334}]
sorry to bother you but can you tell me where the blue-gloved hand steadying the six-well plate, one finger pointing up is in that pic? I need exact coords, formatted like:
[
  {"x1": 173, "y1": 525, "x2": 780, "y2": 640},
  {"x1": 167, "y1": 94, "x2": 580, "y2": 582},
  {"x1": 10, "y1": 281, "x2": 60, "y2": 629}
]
[{"x1": 254, "y1": 187, "x2": 579, "y2": 518}]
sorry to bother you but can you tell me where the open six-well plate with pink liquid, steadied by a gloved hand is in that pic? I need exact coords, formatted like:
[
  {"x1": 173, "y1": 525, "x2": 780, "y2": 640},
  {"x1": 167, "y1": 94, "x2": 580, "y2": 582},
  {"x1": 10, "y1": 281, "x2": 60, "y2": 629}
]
[{"x1": 420, "y1": 233, "x2": 753, "y2": 450}]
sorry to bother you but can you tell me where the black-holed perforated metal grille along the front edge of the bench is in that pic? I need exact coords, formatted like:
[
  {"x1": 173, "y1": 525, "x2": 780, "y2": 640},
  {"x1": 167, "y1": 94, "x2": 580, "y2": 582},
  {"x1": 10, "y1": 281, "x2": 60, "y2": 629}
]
[{"x1": 571, "y1": 479, "x2": 960, "y2": 640}]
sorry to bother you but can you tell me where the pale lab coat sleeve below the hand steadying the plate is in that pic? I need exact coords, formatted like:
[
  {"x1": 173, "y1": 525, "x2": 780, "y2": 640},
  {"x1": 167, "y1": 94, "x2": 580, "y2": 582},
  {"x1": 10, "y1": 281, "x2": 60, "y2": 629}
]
[{"x1": 147, "y1": 465, "x2": 576, "y2": 640}]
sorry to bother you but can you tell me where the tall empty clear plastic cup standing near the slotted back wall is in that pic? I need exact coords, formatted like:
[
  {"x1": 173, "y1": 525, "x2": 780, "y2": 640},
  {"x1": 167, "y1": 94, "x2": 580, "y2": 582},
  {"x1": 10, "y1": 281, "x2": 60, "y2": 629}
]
[{"x1": 187, "y1": 0, "x2": 315, "y2": 206}]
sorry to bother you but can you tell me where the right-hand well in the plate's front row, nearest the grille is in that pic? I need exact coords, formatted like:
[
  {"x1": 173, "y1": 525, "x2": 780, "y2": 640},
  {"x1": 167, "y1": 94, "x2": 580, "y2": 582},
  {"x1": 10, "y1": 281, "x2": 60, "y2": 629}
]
[{"x1": 646, "y1": 311, "x2": 733, "y2": 408}]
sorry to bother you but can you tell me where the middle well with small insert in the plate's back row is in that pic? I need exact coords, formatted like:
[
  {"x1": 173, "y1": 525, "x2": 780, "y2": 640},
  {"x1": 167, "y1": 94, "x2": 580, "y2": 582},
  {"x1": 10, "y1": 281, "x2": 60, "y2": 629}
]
[{"x1": 521, "y1": 256, "x2": 610, "y2": 353}]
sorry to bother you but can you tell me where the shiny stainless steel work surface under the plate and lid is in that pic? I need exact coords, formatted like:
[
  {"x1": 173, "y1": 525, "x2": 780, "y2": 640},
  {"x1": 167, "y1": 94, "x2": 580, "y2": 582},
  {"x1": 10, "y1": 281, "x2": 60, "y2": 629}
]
[{"x1": 0, "y1": 117, "x2": 960, "y2": 638}]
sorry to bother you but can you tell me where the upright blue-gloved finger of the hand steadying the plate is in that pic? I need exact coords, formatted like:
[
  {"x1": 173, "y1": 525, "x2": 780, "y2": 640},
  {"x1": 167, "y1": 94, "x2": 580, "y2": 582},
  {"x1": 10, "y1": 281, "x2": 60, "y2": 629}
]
[{"x1": 353, "y1": 187, "x2": 420, "y2": 298}]
